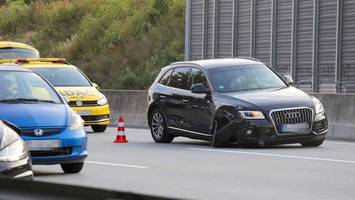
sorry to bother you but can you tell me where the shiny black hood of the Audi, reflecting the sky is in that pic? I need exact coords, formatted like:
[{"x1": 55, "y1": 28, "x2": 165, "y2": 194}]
[{"x1": 222, "y1": 86, "x2": 314, "y2": 112}]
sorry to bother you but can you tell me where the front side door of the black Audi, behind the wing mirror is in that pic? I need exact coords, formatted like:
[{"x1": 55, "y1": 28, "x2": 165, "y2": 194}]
[{"x1": 184, "y1": 67, "x2": 213, "y2": 134}]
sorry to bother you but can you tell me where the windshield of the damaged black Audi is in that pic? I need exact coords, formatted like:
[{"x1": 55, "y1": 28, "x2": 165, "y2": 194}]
[{"x1": 208, "y1": 65, "x2": 286, "y2": 93}]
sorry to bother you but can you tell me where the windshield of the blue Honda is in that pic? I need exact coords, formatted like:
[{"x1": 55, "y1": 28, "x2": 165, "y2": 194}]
[{"x1": 0, "y1": 71, "x2": 62, "y2": 103}]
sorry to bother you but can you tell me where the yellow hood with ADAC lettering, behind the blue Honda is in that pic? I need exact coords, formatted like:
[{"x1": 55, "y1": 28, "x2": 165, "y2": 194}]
[{"x1": 55, "y1": 87, "x2": 103, "y2": 101}]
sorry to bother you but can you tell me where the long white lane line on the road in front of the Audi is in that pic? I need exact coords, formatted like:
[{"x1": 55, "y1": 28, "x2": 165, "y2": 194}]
[{"x1": 189, "y1": 148, "x2": 355, "y2": 164}]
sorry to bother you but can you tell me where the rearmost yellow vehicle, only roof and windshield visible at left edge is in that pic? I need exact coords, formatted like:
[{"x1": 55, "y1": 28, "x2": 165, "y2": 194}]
[{"x1": 0, "y1": 41, "x2": 39, "y2": 59}]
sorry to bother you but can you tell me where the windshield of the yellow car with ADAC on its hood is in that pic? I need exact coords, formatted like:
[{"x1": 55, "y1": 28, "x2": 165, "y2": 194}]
[{"x1": 32, "y1": 67, "x2": 91, "y2": 87}]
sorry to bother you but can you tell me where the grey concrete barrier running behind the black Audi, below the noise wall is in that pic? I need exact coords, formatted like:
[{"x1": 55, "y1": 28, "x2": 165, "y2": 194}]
[{"x1": 102, "y1": 90, "x2": 355, "y2": 141}]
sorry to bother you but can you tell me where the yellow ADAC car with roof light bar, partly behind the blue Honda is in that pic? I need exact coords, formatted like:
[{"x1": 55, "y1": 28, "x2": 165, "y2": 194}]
[{"x1": 0, "y1": 58, "x2": 110, "y2": 132}]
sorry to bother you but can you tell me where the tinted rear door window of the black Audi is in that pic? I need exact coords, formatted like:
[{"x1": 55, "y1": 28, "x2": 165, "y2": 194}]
[{"x1": 169, "y1": 67, "x2": 191, "y2": 90}]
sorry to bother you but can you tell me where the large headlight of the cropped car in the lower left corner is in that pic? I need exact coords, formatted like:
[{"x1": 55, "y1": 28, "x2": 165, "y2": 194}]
[{"x1": 0, "y1": 124, "x2": 27, "y2": 162}]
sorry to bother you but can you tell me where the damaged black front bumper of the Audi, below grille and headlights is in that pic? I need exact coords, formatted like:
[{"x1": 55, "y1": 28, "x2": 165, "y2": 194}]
[{"x1": 211, "y1": 113, "x2": 328, "y2": 147}]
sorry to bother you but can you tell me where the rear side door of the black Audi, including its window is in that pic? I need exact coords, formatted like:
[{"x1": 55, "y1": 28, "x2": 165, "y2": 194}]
[{"x1": 160, "y1": 67, "x2": 191, "y2": 129}]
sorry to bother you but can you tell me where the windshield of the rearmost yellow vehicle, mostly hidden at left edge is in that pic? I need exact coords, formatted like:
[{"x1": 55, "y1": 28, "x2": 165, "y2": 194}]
[{"x1": 0, "y1": 48, "x2": 39, "y2": 59}]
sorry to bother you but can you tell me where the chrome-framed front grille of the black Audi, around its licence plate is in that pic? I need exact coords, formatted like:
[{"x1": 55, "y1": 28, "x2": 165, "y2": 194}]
[{"x1": 270, "y1": 108, "x2": 313, "y2": 133}]
